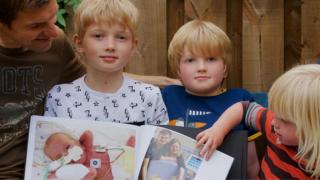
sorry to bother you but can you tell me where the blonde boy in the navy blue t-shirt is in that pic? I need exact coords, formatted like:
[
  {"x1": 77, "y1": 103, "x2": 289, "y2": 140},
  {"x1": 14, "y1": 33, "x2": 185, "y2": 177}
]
[{"x1": 162, "y1": 20, "x2": 259, "y2": 178}]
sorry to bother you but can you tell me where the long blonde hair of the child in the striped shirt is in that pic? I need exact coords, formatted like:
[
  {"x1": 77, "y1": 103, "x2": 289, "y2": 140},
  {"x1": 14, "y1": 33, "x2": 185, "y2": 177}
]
[{"x1": 269, "y1": 64, "x2": 320, "y2": 178}]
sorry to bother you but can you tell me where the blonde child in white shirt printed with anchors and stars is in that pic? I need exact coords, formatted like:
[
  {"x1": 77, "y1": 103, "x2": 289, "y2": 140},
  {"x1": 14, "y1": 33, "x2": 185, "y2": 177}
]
[{"x1": 45, "y1": 0, "x2": 168, "y2": 125}]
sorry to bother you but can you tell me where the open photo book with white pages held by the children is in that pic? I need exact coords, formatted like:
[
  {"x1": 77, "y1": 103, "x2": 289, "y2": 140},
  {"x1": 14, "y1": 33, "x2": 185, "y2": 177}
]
[{"x1": 25, "y1": 116, "x2": 234, "y2": 180}]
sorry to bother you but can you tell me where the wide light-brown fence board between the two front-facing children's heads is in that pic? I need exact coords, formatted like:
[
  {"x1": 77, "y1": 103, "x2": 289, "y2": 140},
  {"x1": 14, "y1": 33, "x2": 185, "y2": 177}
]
[{"x1": 126, "y1": 0, "x2": 167, "y2": 75}]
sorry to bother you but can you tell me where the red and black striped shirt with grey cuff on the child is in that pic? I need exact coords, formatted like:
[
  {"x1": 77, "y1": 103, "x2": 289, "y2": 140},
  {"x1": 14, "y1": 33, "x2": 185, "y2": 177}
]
[{"x1": 244, "y1": 103, "x2": 311, "y2": 179}]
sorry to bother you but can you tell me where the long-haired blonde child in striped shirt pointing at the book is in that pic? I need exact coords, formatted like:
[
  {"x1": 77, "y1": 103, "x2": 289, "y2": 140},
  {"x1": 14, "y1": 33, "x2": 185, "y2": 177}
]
[{"x1": 197, "y1": 64, "x2": 320, "y2": 179}]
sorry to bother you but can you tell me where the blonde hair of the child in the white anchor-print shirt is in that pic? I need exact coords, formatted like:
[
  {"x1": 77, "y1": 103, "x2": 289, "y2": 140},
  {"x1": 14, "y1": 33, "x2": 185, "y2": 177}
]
[{"x1": 74, "y1": 0, "x2": 139, "y2": 38}]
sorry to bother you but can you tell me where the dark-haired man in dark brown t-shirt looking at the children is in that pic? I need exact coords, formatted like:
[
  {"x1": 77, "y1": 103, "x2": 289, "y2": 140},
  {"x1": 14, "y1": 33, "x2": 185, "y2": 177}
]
[{"x1": 0, "y1": 0, "x2": 179, "y2": 179}]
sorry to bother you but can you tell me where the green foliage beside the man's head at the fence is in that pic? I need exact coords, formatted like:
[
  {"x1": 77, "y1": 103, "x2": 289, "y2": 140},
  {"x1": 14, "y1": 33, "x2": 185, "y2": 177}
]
[{"x1": 57, "y1": 0, "x2": 81, "y2": 29}]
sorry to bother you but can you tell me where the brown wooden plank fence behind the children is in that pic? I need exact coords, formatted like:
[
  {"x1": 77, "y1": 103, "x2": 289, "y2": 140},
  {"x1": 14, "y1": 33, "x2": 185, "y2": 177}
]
[{"x1": 126, "y1": 0, "x2": 320, "y2": 91}]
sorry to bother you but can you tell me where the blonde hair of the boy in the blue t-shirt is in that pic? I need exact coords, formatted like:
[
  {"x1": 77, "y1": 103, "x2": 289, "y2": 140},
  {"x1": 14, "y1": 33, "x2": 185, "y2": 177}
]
[{"x1": 168, "y1": 20, "x2": 231, "y2": 76}]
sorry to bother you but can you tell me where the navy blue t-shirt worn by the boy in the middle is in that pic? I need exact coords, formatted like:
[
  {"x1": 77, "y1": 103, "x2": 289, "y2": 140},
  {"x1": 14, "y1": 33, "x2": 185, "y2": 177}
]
[{"x1": 161, "y1": 85, "x2": 254, "y2": 135}]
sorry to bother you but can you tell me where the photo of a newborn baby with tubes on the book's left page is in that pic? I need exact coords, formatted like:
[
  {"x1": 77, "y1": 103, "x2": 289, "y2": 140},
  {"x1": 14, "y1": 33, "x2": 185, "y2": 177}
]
[{"x1": 25, "y1": 117, "x2": 136, "y2": 180}]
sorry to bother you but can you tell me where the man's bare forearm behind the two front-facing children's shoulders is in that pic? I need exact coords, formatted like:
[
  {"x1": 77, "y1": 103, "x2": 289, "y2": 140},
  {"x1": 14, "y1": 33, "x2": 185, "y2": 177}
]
[{"x1": 125, "y1": 73, "x2": 182, "y2": 88}]
